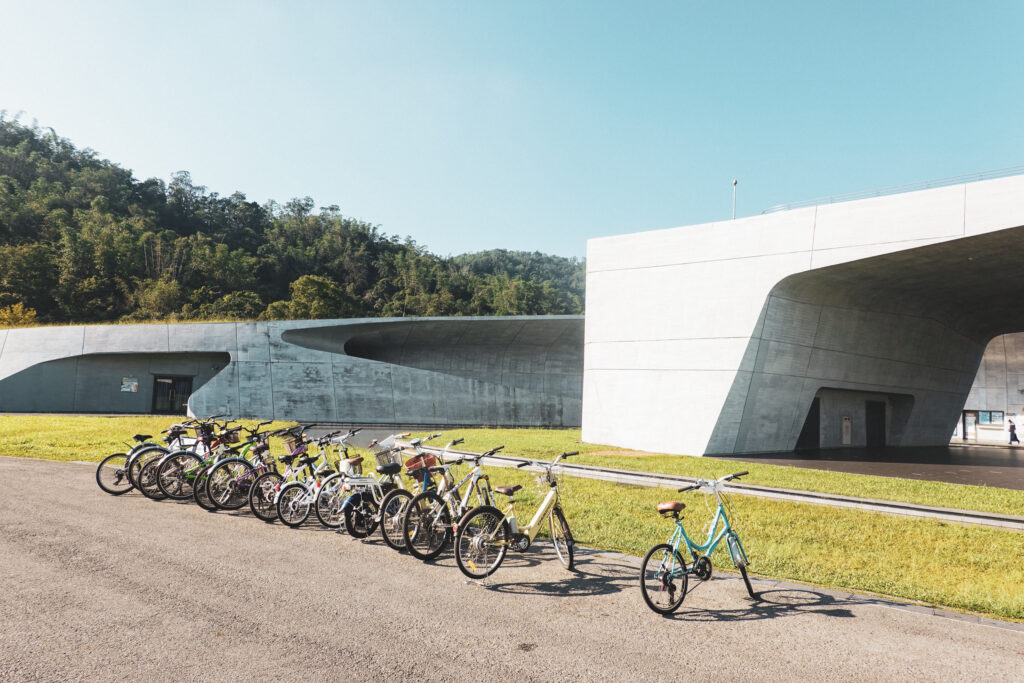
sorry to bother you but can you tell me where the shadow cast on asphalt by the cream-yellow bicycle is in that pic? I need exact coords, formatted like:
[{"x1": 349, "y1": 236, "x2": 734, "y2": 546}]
[{"x1": 478, "y1": 551, "x2": 637, "y2": 597}]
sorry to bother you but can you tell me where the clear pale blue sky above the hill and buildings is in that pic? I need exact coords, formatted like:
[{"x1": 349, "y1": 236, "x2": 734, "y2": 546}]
[{"x1": 0, "y1": 0, "x2": 1024, "y2": 256}]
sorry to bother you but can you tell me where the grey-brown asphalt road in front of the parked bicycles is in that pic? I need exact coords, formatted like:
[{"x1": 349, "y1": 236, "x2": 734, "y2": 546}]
[{"x1": 0, "y1": 458, "x2": 1024, "y2": 681}]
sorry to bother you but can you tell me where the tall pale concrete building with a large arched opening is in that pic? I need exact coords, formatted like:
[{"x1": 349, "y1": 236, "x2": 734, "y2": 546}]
[{"x1": 583, "y1": 175, "x2": 1024, "y2": 455}]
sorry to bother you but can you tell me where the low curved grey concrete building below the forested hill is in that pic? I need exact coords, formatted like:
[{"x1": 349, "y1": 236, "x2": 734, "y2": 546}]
[{"x1": 0, "y1": 315, "x2": 583, "y2": 427}]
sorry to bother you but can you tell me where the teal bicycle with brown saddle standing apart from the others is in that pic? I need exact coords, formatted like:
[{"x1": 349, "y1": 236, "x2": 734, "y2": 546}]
[{"x1": 640, "y1": 472, "x2": 757, "y2": 614}]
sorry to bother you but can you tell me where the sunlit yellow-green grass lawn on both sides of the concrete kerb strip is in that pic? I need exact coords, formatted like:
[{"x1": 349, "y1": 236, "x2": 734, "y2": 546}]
[{"x1": 0, "y1": 416, "x2": 1024, "y2": 621}]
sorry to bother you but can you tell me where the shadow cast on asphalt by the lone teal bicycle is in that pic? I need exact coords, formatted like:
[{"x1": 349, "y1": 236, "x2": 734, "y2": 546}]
[{"x1": 665, "y1": 577, "x2": 870, "y2": 623}]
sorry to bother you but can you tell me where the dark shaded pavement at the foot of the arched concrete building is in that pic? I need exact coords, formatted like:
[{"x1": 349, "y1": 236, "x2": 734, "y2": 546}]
[{"x1": 715, "y1": 445, "x2": 1024, "y2": 490}]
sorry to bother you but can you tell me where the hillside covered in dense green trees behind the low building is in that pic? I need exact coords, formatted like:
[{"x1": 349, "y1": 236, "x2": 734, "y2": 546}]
[{"x1": 0, "y1": 113, "x2": 584, "y2": 325}]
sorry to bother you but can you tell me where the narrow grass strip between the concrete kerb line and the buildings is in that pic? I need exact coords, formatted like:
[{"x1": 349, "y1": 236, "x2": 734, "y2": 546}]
[{"x1": 437, "y1": 429, "x2": 1024, "y2": 516}]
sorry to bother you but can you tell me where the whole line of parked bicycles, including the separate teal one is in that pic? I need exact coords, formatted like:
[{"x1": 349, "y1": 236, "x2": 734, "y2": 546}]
[{"x1": 96, "y1": 416, "x2": 755, "y2": 613}]
